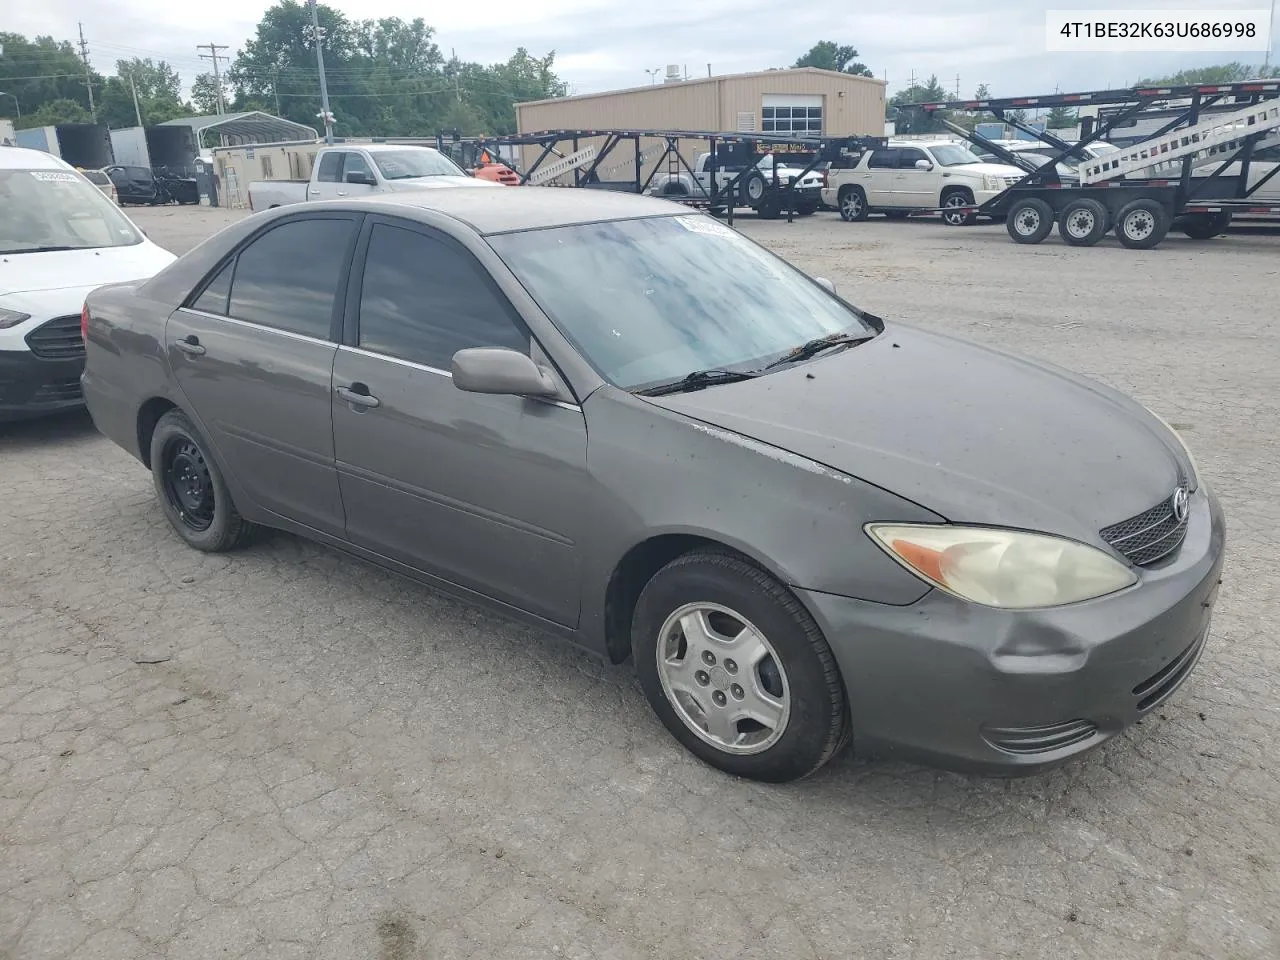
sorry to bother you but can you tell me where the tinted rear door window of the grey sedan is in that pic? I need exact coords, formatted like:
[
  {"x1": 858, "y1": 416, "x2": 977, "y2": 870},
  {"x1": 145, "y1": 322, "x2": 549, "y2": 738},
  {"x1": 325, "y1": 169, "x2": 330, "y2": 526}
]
[{"x1": 226, "y1": 218, "x2": 355, "y2": 340}]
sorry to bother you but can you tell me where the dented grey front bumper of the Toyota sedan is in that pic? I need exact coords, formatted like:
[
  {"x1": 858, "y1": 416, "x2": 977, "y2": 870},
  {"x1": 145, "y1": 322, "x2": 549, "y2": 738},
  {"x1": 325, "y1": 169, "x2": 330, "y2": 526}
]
[{"x1": 799, "y1": 484, "x2": 1226, "y2": 774}]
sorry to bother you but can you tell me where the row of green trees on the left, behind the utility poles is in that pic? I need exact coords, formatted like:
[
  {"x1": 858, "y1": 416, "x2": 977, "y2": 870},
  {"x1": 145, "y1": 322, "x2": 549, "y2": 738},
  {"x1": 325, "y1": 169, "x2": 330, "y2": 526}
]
[{"x1": 0, "y1": 0, "x2": 568, "y2": 137}]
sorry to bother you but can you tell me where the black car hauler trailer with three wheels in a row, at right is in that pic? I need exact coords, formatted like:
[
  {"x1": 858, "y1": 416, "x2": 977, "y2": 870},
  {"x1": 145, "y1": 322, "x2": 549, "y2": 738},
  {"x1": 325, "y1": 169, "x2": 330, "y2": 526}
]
[{"x1": 901, "y1": 79, "x2": 1280, "y2": 250}]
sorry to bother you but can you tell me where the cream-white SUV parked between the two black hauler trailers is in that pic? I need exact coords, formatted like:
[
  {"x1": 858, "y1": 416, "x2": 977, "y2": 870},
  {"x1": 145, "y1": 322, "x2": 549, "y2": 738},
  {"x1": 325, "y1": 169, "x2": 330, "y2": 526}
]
[{"x1": 822, "y1": 141, "x2": 1027, "y2": 225}]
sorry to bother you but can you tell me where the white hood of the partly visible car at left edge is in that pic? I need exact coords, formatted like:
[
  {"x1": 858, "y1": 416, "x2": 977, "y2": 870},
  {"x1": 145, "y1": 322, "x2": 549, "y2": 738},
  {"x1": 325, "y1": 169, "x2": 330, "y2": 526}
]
[{"x1": 0, "y1": 241, "x2": 177, "y2": 296}]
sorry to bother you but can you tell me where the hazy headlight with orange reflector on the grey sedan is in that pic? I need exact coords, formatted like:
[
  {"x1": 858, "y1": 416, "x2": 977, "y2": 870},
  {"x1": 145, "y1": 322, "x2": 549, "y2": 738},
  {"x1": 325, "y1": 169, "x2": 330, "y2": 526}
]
[{"x1": 867, "y1": 524, "x2": 1138, "y2": 611}]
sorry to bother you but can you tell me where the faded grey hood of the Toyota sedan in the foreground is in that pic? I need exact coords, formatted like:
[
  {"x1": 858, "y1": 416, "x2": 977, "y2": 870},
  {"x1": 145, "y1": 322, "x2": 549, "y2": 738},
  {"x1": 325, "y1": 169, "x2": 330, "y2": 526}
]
[{"x1": 645, "y1": 324, "x2": 1184, "y2": 541}]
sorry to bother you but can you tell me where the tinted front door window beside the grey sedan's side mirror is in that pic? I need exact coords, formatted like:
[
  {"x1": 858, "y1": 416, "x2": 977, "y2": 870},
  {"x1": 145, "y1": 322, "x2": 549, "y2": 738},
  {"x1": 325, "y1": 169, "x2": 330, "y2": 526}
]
[{"x1": 358, "y1": 224, "x2": 530, "y2": 370}]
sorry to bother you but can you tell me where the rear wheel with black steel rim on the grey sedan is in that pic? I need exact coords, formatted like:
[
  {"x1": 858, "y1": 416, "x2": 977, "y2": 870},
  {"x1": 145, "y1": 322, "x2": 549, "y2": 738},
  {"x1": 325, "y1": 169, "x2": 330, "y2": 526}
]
[{"x1": 151, "y1": 410, "x2": 259, "y2": 553}]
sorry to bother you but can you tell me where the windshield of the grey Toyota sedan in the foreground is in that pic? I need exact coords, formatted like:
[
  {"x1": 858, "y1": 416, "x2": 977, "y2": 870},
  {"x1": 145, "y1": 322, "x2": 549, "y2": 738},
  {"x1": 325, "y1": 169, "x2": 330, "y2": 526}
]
[{"x1": 489, "y1": 214, "x2": 876, "y2": 390}]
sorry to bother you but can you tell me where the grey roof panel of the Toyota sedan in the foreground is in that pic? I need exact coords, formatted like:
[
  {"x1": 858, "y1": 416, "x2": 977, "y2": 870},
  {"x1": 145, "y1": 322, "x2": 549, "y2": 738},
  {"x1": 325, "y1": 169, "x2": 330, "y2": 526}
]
[{"x1": 350, "y1": 186, "x2": 695, "y2": 234}]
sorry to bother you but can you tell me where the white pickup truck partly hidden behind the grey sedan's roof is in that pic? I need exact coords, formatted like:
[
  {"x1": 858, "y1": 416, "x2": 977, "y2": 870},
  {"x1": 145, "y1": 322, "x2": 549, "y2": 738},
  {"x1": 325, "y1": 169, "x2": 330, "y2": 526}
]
[{"x1": 248, "y1": 143, "x2": 502, "y2": 210}]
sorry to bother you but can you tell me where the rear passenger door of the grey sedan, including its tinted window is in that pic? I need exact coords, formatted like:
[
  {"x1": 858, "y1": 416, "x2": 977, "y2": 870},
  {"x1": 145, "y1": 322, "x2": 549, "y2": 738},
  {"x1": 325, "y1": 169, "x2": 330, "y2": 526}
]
[{"x1": 165, "y1": 214, "x2": 357, "y2": 536}]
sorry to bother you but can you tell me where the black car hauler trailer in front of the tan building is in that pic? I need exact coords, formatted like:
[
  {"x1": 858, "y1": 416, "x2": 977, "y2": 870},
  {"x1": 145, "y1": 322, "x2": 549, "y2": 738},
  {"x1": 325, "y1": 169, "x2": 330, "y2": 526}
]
[{"x1": 481, "y1": 128, "x2": 887, "y2": 224}]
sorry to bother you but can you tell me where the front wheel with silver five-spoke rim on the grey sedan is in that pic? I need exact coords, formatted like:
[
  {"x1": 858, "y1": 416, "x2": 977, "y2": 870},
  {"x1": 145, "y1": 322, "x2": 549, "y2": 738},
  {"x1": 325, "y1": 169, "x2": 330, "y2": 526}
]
[{"x1": 631, "y1": 550, "x2": 849, "y2": 783}]
